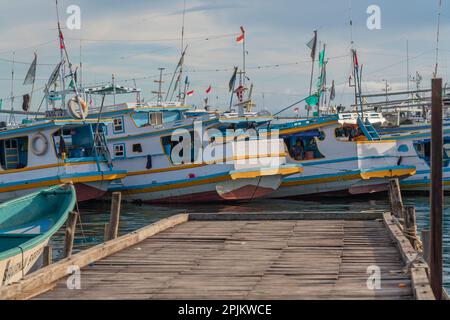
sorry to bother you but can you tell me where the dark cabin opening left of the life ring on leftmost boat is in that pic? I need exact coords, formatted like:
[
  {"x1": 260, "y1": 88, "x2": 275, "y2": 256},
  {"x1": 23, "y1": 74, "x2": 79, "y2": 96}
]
[{"x1": 0, "y1": 137, "x2": 28, "y2": 170}]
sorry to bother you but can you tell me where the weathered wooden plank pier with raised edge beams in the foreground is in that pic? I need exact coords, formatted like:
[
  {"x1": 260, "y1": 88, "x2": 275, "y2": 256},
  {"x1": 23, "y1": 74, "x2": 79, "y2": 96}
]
[{"x1": 0, "y1": 212, "x2": 434, "y2": 300}]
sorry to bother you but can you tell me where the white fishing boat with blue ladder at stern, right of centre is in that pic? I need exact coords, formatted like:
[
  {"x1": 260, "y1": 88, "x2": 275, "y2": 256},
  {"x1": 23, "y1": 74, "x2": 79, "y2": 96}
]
[{"x1": 221, "y1": 115, "x2": 416, "y2": 198}]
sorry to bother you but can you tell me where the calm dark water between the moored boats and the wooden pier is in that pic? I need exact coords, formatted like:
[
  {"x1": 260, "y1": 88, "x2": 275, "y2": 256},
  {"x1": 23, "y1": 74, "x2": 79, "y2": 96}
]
[{"x1": 51, "y1": 195, "x2": 450, "y2": 291}]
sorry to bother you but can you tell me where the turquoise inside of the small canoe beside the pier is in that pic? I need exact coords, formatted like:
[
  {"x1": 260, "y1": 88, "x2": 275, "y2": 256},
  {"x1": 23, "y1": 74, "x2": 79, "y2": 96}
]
[{"x1": 0, "y1": 184, "x2": 76, "y2": 261}]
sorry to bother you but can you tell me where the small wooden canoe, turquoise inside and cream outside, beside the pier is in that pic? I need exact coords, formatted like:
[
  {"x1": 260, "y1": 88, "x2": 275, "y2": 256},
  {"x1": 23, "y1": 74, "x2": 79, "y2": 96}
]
[{"x1": 0, "y1": 184, "x2": 76, "y2": 287}]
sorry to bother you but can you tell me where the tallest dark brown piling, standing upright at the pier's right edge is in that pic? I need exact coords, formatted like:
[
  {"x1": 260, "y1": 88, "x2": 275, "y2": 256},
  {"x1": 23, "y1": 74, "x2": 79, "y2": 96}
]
[{"x1": 430, "y1": 78, "x2": 444, "y2": 300}]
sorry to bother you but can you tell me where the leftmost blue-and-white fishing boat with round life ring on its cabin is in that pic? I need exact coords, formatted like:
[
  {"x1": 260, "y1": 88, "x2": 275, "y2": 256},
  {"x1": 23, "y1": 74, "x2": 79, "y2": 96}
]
[{"x1": 0, "y1": 119, "x2": 126, "y2": 202}]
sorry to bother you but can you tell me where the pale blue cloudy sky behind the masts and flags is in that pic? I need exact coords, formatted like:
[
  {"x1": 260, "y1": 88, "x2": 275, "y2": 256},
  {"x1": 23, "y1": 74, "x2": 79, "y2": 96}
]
[{"x1": 0, "y1": 0, "x2": 450, "y2": 115}]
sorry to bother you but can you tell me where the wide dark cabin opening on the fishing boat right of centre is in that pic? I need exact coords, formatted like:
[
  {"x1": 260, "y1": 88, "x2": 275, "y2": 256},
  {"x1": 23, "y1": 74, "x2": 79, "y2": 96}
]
[{"x1": 284, "y1": 130, "x2": 325, "y2": 161}]
